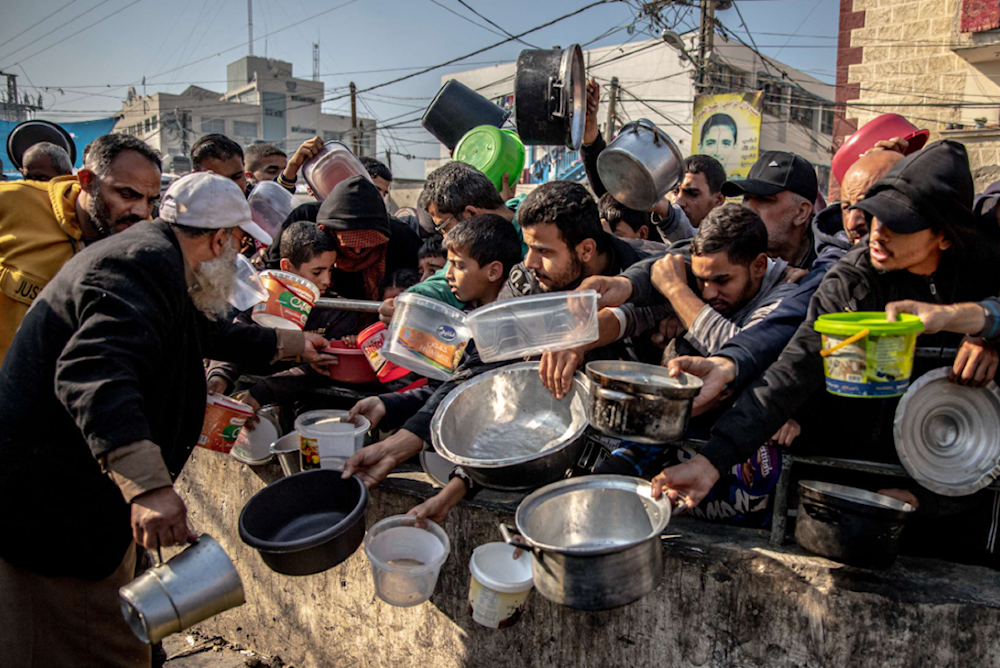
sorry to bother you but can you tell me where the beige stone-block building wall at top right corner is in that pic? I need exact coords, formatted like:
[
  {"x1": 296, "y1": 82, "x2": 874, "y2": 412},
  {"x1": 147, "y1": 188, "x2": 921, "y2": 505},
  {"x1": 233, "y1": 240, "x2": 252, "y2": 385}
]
[{"x1": 834, "y1": 0, "x2": 1000, "y2": 190}]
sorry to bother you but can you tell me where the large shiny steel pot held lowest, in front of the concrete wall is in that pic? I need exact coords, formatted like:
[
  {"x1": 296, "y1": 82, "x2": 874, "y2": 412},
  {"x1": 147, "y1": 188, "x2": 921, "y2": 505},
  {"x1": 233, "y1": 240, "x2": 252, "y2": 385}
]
[{"x1": 500, "y1": 475, "x2": 673, "y2": 610}]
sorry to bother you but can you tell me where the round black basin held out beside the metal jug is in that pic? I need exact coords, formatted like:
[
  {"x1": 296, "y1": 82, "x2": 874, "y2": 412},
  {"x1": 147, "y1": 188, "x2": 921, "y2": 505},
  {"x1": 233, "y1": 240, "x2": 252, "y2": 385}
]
[{"x1": 240, "y1": 469, "x2": 368, "y2": 575}]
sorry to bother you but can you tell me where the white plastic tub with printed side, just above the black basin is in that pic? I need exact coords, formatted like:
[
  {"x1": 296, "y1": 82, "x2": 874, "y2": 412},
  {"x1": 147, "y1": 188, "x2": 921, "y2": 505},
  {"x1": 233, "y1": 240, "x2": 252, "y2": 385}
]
[{"x1": 295, "y1": 410, "x2": 371, "y2": 471}]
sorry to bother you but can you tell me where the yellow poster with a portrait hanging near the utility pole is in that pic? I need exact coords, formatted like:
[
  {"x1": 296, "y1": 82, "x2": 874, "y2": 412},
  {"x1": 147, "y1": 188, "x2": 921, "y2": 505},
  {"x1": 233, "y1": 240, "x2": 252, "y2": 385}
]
[{"x1": 691, "y1": 91, "x2": 764, "y2": 178}]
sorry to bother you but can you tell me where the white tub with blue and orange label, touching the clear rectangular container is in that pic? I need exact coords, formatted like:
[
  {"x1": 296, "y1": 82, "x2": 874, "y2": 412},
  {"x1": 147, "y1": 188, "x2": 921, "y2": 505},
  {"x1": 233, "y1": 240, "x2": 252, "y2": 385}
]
[{"x1": 382, "y1": 292, "x2": 474, "y2": 380}]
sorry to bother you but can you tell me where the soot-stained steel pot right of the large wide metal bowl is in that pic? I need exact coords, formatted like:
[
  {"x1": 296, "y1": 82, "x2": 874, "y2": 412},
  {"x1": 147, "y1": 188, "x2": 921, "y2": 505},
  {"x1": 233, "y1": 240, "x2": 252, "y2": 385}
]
[{"x1": 586, "y1": 361, "x2": 702, "y2": 443}]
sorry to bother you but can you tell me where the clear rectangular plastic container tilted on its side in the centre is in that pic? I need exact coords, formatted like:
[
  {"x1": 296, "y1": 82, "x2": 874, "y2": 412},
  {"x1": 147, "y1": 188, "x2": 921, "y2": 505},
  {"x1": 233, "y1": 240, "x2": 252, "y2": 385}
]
[{"x1": 465, "y1": 290, "x2": 598, "y2": 362}]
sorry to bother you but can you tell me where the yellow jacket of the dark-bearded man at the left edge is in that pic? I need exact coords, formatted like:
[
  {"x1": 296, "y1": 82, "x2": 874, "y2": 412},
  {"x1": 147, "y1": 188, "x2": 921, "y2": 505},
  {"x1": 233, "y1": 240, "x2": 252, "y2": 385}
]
[{"x1": 0, "y1": 176, "x2": 83, "y2": 362}]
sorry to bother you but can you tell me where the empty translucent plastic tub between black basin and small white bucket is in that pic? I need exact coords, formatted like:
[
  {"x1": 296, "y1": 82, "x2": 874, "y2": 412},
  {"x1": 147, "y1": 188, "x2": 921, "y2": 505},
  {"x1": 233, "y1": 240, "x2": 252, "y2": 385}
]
[{"x1": 365, "y1": 515, "x2": 451, "y2": 608}]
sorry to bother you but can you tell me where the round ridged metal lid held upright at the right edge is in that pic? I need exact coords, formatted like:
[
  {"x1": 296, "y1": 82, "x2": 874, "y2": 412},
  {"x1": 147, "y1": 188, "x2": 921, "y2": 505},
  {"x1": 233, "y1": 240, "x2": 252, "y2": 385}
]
[{"x1": 893, "y1": 367, "x2": 1000, "y2": 496}]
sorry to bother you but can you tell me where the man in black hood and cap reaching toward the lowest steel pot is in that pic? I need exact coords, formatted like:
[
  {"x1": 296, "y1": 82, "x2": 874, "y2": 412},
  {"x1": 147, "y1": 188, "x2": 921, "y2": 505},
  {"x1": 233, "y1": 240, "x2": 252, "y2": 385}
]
[{"x1": 654, "y1": 141, "x2": 1000, "y2": 568}]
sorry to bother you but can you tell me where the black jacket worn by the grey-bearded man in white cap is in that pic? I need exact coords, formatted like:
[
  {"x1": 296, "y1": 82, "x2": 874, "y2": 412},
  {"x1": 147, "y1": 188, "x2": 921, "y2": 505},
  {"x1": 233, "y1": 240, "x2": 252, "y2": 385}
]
[{"x1": 0, "y1": 220, "x2": 276, "y2": 579}]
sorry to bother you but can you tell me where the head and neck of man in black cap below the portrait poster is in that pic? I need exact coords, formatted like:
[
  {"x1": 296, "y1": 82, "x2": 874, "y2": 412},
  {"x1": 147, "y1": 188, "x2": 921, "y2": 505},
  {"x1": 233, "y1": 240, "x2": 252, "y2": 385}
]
[{"x1": 722, "y1": 151, "x2": 819, "y2": 269}]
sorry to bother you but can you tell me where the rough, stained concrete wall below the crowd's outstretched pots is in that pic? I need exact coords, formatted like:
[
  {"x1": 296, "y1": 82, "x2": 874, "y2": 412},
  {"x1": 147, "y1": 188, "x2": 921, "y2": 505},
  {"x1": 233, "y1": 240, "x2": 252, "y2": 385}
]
[{"x1": 177, "y1": 450, "x2": 1000, "y2": 668}]
